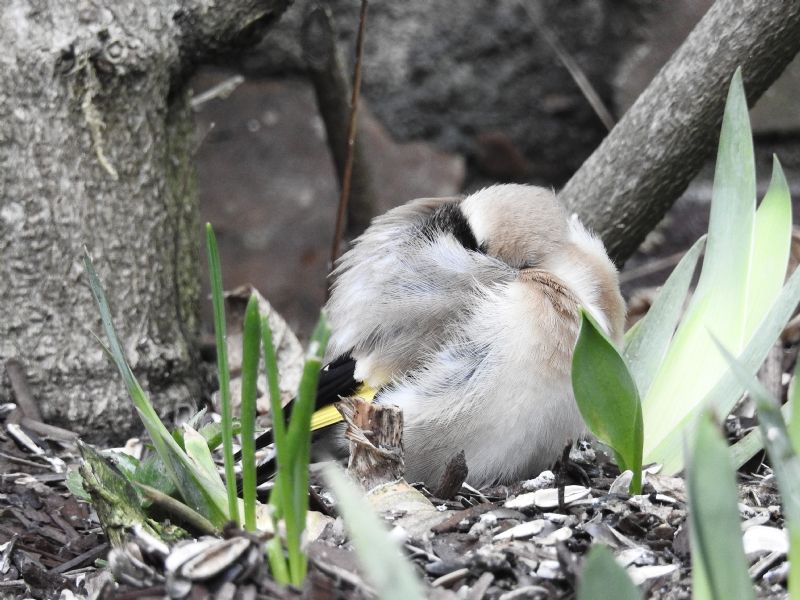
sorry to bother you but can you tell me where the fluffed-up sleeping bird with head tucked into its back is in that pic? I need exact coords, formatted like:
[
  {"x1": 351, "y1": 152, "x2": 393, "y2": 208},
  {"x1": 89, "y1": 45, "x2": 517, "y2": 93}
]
[{"x1": 257, "y1": 184, "x2": 625, "y2": 487}]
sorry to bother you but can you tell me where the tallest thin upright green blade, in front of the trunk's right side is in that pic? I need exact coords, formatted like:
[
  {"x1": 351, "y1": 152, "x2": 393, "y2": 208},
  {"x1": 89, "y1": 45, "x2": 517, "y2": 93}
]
[{"x1": 206, "y1": 223, "x2": 241, "y2": 525}]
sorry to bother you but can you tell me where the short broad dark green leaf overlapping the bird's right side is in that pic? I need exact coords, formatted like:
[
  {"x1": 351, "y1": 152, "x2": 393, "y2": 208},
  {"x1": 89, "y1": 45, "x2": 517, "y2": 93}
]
[{"x1": 572, "y1": 309, "x2": 643, "y2": 494}]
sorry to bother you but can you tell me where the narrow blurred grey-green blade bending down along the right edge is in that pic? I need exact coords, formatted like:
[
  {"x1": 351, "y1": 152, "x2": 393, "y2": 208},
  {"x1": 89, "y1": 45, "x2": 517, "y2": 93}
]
[{"x1": 720, "y1": 345, "x2": 800, "y2": 598}]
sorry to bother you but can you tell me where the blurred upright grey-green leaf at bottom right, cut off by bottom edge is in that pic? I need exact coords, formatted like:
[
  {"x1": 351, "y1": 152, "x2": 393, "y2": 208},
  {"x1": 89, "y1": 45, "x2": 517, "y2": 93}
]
[{"x1": 687, "y1": 415, "x2": 755, "y2": 600}]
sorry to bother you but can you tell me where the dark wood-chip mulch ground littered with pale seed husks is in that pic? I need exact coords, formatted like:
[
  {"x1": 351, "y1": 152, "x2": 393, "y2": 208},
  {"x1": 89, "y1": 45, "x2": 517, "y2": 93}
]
[{"x1": 0, "y1": 407, "x2": 787, "y2": 600}]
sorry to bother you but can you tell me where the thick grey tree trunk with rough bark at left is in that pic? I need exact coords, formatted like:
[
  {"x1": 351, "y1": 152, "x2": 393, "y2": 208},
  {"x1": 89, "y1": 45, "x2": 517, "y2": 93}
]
[{"x1": 0, "y1": 0, "x2": 288, "y2": 439}]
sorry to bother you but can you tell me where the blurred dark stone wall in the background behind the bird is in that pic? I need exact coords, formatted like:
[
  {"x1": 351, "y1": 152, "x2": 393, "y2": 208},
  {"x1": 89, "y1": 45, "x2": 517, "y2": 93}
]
[{"x1": 192, "y1": 0, "x2": 800, "y2": 337}]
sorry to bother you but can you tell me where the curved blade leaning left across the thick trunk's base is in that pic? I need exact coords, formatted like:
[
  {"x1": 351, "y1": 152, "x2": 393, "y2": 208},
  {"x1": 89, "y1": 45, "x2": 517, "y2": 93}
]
[{"x1": 84, "y1": 251, "x2": 226, "y2": 526}]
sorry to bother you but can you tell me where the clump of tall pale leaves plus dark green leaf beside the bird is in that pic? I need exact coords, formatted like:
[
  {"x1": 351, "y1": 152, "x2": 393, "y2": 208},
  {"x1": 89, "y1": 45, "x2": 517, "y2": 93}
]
[{"x1": 573, "y1": 70, "x2": 800, "y2": 490}]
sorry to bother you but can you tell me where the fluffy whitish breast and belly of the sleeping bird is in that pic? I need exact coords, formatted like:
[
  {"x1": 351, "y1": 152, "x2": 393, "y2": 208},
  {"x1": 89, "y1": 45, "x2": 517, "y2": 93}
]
[{"x1": 380, "y1": 282, "x2": 584, "y2": 485}]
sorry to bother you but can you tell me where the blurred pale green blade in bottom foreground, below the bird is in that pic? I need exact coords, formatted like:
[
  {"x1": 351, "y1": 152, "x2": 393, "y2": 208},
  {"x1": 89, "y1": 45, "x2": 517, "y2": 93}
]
[{"x1": 325, "y1": 465, "x2": 425, "y2": 600}]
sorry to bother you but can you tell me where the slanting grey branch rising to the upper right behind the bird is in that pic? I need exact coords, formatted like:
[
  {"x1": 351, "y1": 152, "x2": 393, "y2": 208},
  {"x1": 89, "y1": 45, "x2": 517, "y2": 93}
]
[{"x1": 560, "y1": 0, "x2": 800, "y2": 264}]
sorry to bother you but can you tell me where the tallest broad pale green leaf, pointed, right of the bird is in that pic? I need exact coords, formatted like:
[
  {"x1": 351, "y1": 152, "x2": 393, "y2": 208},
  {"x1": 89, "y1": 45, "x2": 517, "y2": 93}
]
[{"x1": 642, "y1": 70, "x2": 763, "y2": 466}]
